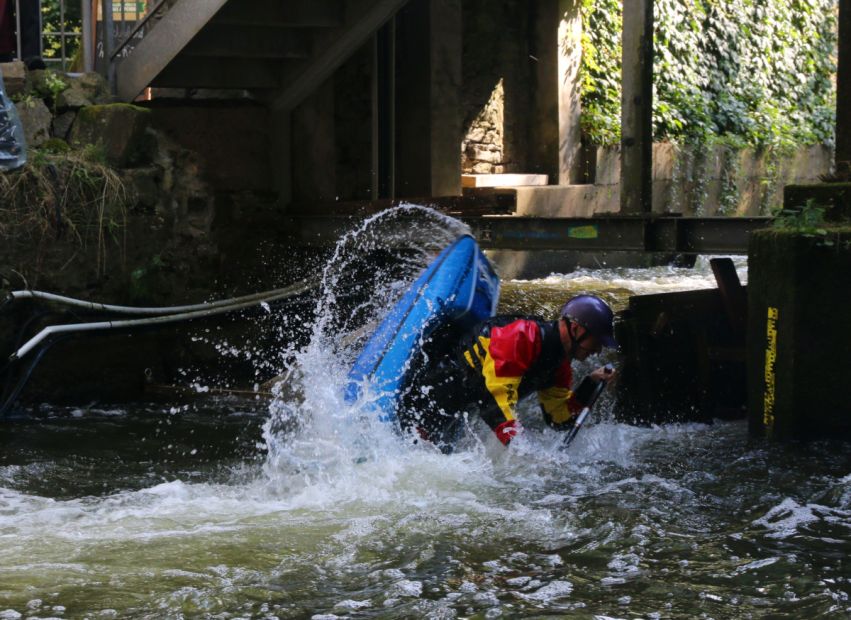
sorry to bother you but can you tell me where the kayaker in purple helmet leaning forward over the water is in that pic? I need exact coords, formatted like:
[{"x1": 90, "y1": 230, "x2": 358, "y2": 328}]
[{"x1": 399, "y1": 295, "x2": 617, "y2": 450}]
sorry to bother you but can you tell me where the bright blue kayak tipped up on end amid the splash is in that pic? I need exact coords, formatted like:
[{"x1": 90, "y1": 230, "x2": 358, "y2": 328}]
[{"x1": 345, "y1": 235, "x2": 499, "y2": 422}]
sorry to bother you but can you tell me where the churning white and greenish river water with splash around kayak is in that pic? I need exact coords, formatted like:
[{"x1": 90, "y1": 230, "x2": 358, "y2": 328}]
[{"x1": 0, "y1": 209, "x2": 851, "y2": 618}]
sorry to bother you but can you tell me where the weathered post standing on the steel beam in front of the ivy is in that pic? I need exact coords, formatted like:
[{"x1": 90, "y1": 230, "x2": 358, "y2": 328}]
[{"x1": 620, "y1": 0, "x2": 653, "y2": 214}]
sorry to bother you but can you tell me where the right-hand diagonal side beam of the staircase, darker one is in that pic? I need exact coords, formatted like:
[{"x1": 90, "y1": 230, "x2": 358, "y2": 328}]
[{"x1": 272, "y1": 0, "x2": 406, "y2": 110}]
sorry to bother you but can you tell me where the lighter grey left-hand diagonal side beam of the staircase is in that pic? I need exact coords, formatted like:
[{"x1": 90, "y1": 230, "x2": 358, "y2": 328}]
[{"x1": 116, "y1": 0, "x2": 227, "y2": 101}]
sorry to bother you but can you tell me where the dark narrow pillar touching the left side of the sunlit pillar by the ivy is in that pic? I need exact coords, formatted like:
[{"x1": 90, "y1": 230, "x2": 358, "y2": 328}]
[{"x1": 526, "y1": 0, "x2": 561, "y2": 185}]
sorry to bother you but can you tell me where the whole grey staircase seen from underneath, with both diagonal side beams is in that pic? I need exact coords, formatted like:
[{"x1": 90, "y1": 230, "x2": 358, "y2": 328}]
[{"x1": 115, "y1": 0, "x2": 406, "y2": 109}]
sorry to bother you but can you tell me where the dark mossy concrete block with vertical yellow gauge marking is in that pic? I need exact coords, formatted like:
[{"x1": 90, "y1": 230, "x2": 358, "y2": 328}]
[{"x1": 748, "y1": 227, "x2": 851, "y2": 440}]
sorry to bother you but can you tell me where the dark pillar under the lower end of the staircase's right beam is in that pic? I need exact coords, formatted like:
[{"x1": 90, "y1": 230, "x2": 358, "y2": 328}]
[{"x1": 290, "y1": 77, "x2": 337, "y2": 203}]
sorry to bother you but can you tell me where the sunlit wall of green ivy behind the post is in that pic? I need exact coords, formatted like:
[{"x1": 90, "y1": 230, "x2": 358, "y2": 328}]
[{"x1": 580, "y1": 0, "x2": 837, "y2": 148}]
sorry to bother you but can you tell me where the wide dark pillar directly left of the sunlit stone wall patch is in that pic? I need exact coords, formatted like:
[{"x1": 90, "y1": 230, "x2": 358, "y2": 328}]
[{"x1": 395, "y1": 0, "x2": 462, "y2": 197}]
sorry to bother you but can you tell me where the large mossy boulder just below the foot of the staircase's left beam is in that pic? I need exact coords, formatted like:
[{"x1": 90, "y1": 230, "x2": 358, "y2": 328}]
[{"x1": 69, "y1": 103, "x2": 156, "y2": 168}]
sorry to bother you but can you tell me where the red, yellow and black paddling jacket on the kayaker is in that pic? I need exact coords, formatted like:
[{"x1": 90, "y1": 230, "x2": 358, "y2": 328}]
[{"x1": 462, "y1": 317, "x2": 583, "y2": 445}]
